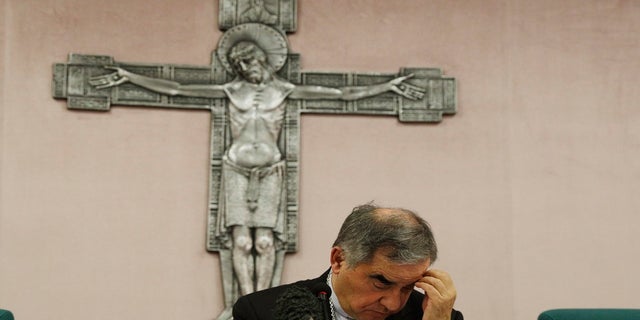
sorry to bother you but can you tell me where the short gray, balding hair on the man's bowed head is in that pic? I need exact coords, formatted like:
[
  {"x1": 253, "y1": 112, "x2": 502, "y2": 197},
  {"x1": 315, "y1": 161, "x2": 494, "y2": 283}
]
[{"x1": 333, "y1": 204, "x2": 438, "y2": 268}]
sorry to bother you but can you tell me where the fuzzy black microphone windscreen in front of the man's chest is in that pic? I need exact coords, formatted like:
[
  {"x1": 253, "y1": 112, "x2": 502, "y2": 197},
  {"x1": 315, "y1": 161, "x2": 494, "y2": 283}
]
[{"x1": 273, "y1": 285, "x2": 326, "y2": 320}]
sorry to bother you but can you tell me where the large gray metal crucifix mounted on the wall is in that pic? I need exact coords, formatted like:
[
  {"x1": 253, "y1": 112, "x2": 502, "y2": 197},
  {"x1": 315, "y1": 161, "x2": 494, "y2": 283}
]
[{"x1": 53, "y1": 0, "x2": 456, "y2": 319}]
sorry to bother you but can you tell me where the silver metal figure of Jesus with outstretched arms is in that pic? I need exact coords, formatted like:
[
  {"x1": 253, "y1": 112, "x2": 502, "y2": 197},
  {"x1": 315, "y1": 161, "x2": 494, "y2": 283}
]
[{"x1": 90, "y1": 41, "x2": 424, "y2": 295}]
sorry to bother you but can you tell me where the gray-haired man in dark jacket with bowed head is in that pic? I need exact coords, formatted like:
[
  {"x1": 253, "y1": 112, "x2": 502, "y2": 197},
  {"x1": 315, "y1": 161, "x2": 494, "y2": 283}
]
[{"x1": 233, "y1": 205, "x2": 463, "y2": 320}]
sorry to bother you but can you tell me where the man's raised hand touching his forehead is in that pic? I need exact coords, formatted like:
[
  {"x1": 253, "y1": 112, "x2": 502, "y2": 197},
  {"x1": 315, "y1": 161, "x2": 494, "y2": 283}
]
[{"x1": 416, "y1": 269, "x2": 456, "y2": 320}]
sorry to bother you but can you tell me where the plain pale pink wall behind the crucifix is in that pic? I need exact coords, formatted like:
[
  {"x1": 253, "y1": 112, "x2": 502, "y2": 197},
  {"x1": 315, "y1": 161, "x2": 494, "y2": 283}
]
[{"x1": 0, "y1": 0, "x2": 640, "y2": 320}]
